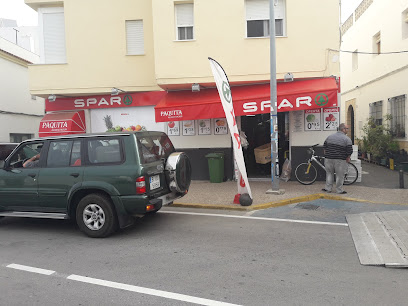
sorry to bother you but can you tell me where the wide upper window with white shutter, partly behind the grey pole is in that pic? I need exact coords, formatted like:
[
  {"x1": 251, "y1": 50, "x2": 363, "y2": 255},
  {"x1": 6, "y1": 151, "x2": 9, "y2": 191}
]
[{"x1": 245, "y1": 0, "x2": 285, "y2": 37}]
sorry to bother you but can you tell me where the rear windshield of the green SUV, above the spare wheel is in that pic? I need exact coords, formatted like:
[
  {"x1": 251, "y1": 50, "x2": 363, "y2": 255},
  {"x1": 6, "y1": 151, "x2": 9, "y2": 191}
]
[{"x1": 136, "y1": 132, "x2": 175, "y2": 163}]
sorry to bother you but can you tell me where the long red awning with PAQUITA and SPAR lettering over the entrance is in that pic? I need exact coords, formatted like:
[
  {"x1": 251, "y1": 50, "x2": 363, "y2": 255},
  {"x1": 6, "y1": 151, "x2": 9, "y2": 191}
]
[{"x1": 155, "y1": 77, "x2": 338, "y2": 122}]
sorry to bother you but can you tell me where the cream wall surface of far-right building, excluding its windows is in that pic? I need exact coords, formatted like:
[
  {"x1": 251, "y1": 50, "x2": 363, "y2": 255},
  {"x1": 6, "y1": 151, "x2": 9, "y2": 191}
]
[{"x1": 340, "y1": 0, "x2": 408, "y2": 143}]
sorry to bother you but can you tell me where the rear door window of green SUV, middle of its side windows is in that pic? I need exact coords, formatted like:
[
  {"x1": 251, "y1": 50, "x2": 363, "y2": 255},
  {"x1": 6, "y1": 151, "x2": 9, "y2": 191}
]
[{"x1": 47, "y1": 140, "x2": 81, "y2": 167}]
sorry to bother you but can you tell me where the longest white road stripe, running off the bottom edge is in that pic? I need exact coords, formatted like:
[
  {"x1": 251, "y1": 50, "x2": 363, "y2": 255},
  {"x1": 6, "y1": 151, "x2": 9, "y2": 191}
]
[{"x1": 67, "y1": 274, "x2": 237, "y2": 306}]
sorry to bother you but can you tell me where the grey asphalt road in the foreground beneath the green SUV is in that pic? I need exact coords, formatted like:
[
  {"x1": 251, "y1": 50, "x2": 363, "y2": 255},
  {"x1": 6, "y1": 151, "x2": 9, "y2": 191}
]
[{"x1": 0, "y1": 207, "x2": 406, "y2": 305}]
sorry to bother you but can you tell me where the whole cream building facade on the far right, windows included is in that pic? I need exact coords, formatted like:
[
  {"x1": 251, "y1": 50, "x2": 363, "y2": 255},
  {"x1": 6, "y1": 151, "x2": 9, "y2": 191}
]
[{"x1": 340, "y1": 0, "x2": 408, "y2": 150}]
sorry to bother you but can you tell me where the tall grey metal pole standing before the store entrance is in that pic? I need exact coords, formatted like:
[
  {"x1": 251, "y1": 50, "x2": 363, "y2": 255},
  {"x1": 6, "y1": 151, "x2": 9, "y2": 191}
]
[{"x1": 266, "y1": 0, "x2": 285, "y2": 194}]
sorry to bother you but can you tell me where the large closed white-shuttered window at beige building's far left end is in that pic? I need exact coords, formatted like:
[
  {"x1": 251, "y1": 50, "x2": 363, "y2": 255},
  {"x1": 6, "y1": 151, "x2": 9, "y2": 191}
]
[{"x1": 38, "y1": 7, "x2": 67, "y2": 64}]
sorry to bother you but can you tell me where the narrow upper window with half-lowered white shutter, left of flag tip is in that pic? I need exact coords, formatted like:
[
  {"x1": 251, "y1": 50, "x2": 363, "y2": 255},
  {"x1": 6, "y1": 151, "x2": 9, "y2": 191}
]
[{"x1": 175, "y1": 3, "x2": 194, "y2": 40}]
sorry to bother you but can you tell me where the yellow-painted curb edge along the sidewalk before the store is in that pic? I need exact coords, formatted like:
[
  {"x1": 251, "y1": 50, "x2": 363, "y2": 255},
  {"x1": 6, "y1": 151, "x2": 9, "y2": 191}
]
[{"x1": 170, "y1": 193, "x2": 408, "y2": 211}]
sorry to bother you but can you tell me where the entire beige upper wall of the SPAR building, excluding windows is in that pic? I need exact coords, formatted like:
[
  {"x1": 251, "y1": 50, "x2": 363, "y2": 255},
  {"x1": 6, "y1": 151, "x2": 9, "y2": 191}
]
[{"x1": 25, "y1": 0, "x2": 339, "y2": 97}]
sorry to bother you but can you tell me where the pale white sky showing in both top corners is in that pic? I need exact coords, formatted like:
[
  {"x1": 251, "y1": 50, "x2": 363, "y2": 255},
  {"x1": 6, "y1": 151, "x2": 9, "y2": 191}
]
[{"x1": 0, "y1": 0, "x2": 362, "y2": 27}]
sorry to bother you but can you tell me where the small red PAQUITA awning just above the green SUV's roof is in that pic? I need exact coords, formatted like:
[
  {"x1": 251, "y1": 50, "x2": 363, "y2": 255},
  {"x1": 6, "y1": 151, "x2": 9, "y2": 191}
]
[{"x1": 39, "y1": 110, "x2": 86, "y2": 137}]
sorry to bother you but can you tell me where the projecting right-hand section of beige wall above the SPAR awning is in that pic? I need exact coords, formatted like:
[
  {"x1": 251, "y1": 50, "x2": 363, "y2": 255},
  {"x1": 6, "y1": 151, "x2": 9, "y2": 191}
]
[{"x1": 152, "y1": 0, "x2": 339, "y2": 85}]
